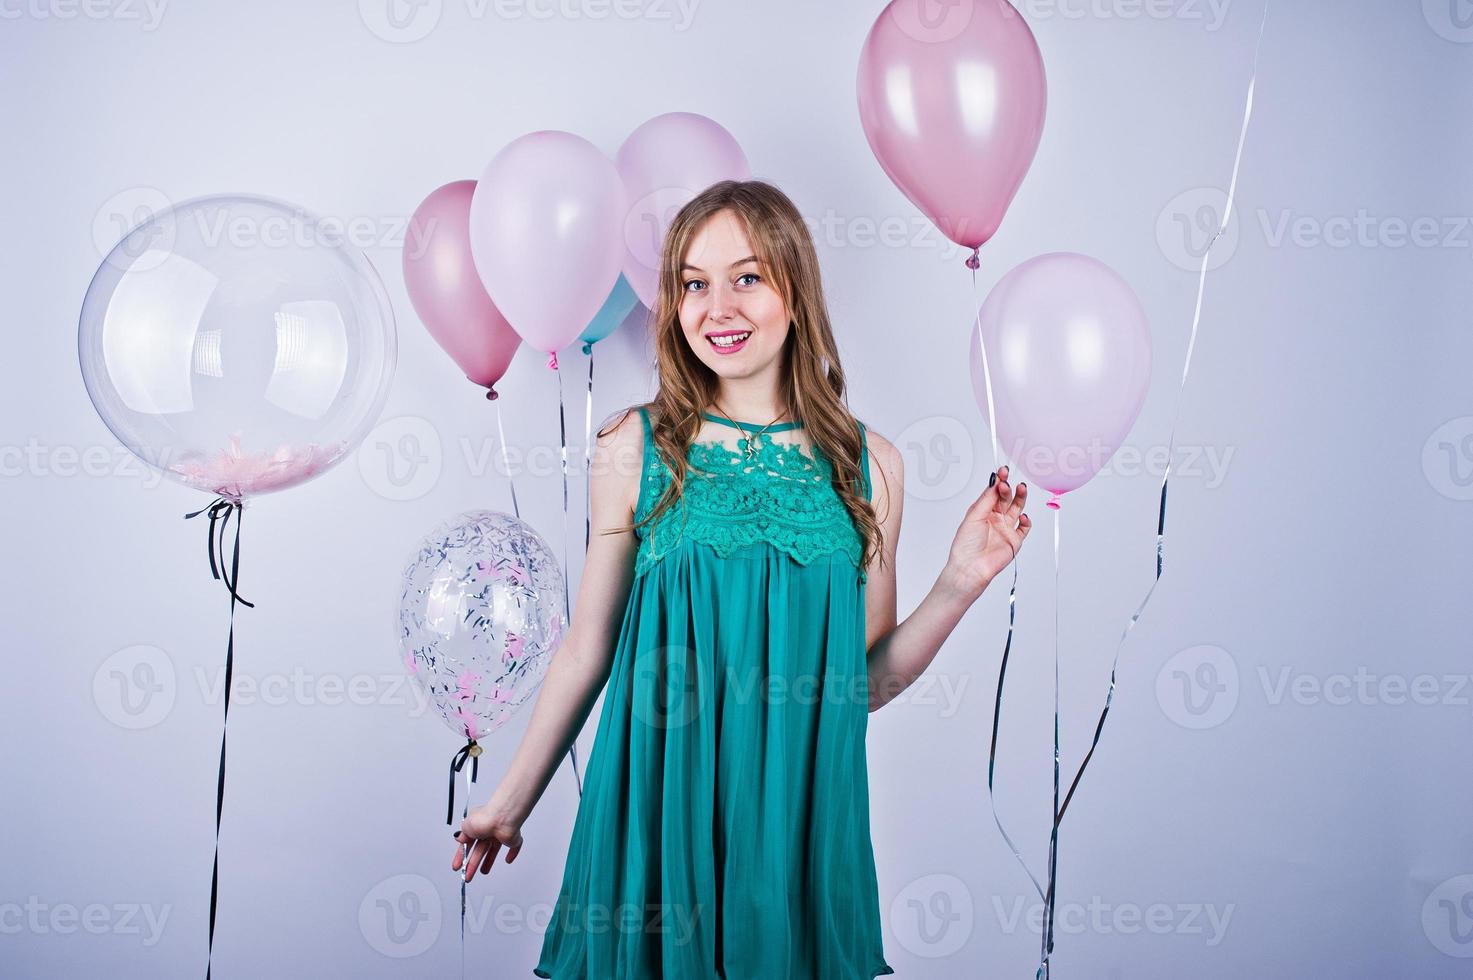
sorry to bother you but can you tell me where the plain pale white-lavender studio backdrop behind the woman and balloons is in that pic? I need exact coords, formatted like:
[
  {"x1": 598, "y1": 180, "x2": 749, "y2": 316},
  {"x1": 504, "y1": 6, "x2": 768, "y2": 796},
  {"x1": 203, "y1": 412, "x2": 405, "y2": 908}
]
[{"x1": 0, "y1": 0, "x2": 1473, "y2": 980}]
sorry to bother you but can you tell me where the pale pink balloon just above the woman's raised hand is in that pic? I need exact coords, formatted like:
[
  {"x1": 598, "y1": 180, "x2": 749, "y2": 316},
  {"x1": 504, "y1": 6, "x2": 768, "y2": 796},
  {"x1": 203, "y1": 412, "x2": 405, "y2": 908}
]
[{"x1": 971, "y1": 252, "x2": 1150, "y2": 507}]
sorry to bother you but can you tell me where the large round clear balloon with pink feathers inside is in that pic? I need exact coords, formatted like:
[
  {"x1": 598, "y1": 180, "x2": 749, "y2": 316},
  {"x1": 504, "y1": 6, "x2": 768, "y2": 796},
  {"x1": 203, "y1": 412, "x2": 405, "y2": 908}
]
[{"x1": 78, "y1": 195, "x2": 395, "y2": 500}]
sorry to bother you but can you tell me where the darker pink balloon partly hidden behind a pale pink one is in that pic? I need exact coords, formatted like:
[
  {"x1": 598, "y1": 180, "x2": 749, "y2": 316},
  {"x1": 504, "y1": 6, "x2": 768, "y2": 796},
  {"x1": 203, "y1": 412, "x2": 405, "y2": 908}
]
[{"x1": 404, "y1": 180, "x2": 521, "y2": 398}]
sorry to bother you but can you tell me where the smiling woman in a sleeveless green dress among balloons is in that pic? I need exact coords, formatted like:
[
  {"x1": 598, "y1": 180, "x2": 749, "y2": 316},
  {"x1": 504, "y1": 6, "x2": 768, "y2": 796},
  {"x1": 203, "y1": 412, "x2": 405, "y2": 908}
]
[{"x1": 452, "y1": 181, "x2": 1031, "y2": 980}]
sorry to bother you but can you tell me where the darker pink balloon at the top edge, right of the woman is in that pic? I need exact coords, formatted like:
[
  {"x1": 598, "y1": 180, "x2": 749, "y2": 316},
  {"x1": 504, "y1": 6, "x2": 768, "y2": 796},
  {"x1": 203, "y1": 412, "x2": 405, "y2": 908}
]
[{"x1": 859, "y1": 0, "x2": 1047, "y2": 256}]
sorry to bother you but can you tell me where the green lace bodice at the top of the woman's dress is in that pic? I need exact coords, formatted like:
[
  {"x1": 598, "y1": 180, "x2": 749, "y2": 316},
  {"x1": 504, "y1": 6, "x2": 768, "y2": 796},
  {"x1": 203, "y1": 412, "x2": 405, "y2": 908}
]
[{"x1": 635, "y1": 408, "x2": 871, "y2": 582}]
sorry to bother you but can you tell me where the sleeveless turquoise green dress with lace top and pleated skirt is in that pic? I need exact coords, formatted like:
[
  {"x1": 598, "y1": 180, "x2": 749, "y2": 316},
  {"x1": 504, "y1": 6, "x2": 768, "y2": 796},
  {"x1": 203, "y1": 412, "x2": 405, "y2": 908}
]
[{"x1": 533, "y1": 408, "x2": 894, "y2": 980}]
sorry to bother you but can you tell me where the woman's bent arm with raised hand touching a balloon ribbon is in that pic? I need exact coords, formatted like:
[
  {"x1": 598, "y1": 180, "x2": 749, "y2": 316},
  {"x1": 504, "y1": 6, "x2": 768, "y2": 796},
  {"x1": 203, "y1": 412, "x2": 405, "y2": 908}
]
[{"x1": 865, "y1": 430, "x2": 1033, "y2": 712}]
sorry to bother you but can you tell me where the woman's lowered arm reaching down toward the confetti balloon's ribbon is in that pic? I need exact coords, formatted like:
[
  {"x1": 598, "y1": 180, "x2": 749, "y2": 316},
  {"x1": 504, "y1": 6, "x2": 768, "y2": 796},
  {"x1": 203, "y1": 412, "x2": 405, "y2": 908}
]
[{"x1": 451, "y1": 411, "x2": 644, "y2": 881}]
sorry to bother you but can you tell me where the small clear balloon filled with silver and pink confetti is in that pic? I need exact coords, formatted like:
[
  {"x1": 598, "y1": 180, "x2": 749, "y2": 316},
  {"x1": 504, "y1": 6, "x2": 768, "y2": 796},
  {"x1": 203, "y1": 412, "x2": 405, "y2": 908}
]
[{"x1": 399, "y1": 510, "x2": 567, "y2": 740}]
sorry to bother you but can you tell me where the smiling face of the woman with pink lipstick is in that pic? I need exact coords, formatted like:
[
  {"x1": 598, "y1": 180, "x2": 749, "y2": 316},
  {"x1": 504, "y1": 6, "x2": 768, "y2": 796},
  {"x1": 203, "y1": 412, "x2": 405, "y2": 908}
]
[{"x1": 679, "y1": 211, "x2": 791, "y2": 388}]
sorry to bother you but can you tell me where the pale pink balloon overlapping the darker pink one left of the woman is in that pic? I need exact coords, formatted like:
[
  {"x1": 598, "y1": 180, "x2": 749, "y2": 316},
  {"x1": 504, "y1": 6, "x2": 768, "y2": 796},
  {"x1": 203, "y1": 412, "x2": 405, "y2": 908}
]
[{"x1": 470, "y1": 130, "x2": 626, "y2": 358}]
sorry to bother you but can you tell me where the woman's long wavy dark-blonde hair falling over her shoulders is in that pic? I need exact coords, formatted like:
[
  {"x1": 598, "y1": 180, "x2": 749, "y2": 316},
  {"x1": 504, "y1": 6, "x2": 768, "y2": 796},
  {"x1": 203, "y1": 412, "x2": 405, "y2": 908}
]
[{"x1": 598, "y1": 180, "x2": 884, "y2": 567}]
